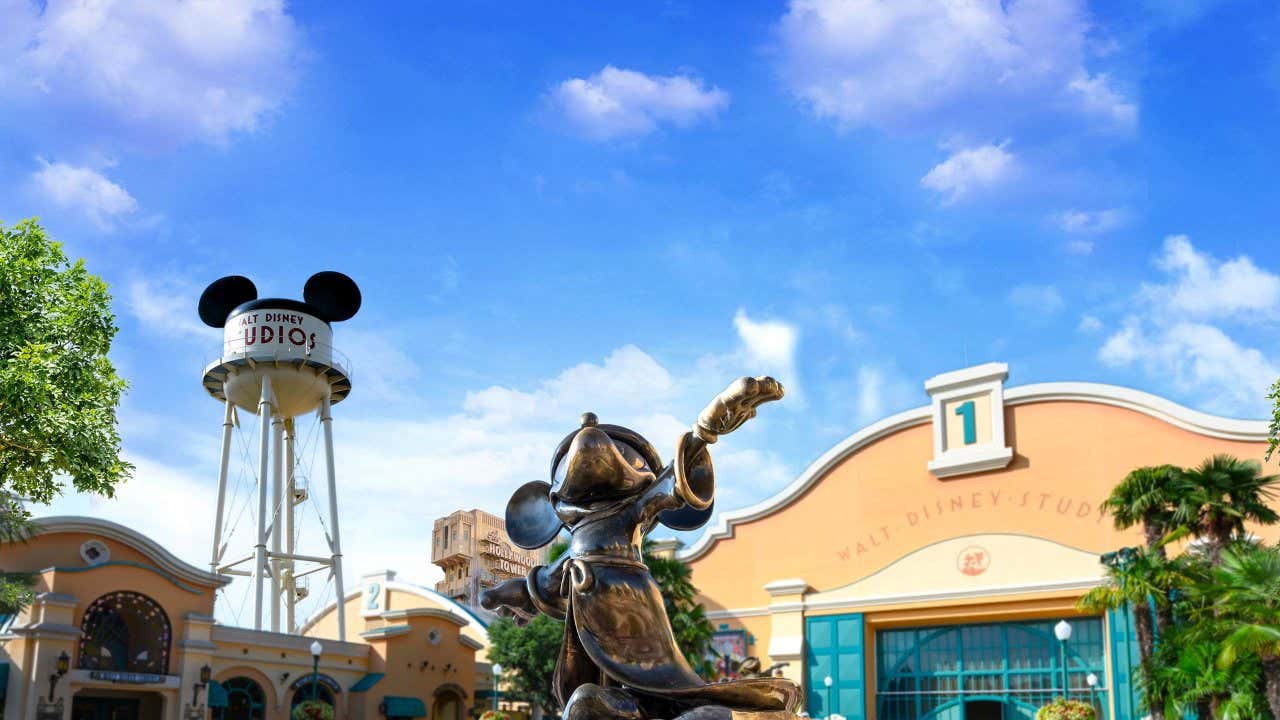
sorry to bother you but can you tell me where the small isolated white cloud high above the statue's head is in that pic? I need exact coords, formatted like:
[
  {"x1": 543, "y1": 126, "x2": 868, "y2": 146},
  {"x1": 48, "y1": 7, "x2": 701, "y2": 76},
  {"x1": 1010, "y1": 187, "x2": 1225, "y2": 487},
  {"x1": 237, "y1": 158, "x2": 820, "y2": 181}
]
[{"x1": 550, "y1": 65, "x2": 728, "y2": 141}]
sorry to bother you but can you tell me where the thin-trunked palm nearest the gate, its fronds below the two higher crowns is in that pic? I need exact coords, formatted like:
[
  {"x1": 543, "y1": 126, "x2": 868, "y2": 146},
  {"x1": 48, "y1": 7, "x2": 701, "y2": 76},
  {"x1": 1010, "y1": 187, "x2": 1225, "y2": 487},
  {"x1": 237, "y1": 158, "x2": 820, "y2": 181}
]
[{"x1": 1076, "y1": 548, "x2": 1176, "y2": 720}]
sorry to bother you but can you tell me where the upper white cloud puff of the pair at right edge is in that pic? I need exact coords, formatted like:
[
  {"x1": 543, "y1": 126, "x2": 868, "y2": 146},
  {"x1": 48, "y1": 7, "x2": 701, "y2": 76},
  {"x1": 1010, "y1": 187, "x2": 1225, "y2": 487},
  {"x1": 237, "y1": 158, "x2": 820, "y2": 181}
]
[{"x1": 1143, "y1": 234, "x2": 1280, "y2": 319}]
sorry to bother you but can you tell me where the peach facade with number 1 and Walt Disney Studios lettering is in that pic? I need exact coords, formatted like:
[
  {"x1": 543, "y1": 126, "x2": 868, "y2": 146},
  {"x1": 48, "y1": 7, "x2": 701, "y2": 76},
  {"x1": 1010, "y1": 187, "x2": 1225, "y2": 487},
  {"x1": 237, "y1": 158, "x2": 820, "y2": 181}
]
[{"x1": 678, "y1": 364, "x2": 1275, "y2": 720}]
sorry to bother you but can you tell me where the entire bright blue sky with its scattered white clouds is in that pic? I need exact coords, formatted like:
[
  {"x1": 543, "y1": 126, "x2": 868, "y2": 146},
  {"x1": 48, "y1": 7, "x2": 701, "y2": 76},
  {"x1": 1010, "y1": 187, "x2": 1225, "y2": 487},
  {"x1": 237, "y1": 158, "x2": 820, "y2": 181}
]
[{"x1": 0, "y1": 0, "x2": 1280, "y2": 619}]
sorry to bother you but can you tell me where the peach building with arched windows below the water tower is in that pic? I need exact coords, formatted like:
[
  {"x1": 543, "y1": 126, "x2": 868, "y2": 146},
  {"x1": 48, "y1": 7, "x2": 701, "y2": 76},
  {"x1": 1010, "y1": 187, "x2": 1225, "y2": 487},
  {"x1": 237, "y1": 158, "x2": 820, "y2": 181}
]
[{"x1": 0, "y1": 518, "x2": 489, "y2": 720}]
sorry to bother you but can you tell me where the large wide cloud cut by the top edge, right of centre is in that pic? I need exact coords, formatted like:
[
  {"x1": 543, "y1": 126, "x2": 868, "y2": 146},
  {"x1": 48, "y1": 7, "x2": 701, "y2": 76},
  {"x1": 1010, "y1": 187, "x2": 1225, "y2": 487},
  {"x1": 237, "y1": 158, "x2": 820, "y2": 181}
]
[{"x1": 778, "y1": 0, "x2": 1137, "y2": 133}]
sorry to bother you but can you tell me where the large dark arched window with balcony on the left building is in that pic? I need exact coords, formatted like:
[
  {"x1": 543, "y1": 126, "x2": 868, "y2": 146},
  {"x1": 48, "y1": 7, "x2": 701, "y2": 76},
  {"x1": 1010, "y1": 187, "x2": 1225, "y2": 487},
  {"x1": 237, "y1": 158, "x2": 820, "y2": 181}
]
[{"x1": 77, "y1": 591, "x2": 173, "y2": 675}]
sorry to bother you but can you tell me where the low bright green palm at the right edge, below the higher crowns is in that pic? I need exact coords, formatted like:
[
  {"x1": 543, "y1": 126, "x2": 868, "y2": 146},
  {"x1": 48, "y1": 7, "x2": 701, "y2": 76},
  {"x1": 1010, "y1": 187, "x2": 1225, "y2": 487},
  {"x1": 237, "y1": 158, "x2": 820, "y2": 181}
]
[{"x1": 1213, "y1": 543, "x2": 1280, "y2": 717}]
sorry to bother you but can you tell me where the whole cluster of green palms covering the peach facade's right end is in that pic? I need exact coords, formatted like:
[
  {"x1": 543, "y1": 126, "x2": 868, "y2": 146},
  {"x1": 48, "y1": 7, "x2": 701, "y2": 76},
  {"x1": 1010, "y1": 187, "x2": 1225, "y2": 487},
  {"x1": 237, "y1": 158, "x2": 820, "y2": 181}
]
[{"x1": 1079, "y1": 455, "x2": 1280, "y2": 720}]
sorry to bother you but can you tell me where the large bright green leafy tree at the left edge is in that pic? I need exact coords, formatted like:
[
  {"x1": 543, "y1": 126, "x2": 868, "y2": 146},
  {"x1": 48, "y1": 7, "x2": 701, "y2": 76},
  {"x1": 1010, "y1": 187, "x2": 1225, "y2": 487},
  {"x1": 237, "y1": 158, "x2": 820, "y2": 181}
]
[{"x1": 0, "y1": 219, "x2": 132, "y2": 609}]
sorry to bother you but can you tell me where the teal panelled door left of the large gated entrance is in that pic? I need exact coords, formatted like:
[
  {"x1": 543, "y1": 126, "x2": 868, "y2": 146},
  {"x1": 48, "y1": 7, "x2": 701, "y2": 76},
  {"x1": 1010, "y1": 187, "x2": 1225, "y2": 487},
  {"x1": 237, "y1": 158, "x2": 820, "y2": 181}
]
[{"x1": 805, "y1": 614, "x2": 867, "y2": 720}]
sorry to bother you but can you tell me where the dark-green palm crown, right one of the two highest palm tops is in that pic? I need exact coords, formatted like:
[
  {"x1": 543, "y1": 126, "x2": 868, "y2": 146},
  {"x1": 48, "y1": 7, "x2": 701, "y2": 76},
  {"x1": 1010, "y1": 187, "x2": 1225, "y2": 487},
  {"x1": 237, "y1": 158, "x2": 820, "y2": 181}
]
[{"x1": 1174, "y1": 454, "x2": 1280, "y2": 565}]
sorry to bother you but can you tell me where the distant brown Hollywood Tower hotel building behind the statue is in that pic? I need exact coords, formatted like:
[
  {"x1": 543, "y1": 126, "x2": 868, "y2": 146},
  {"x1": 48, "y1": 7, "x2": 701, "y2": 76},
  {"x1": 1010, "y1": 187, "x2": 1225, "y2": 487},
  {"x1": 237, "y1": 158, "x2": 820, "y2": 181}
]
[{"x1": 431, "y1": 510, "x2": 547, "y2": 610}]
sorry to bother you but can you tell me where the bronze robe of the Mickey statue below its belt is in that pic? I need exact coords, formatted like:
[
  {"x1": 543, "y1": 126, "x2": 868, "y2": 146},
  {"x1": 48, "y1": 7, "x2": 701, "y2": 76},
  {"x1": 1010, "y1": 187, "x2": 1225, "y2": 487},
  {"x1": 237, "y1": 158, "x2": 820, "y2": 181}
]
[{"x1": 554, "y1": 560, "x2": 800, "y2": 712}]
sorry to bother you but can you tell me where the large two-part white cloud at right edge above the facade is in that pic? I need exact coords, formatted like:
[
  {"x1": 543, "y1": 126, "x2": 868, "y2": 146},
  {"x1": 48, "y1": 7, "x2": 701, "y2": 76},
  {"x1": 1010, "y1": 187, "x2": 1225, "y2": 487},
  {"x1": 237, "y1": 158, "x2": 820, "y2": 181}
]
[{"x1": 1098, "y1": 236, "x2": 1280, "y2": 416}]
